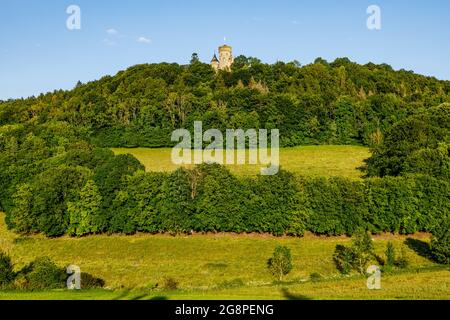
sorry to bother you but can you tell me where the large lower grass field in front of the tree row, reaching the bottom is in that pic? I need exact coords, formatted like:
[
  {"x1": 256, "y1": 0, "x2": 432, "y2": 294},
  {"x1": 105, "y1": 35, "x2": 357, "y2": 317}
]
[{"x1": 0, "y1": 214, "x2": 450, "y2": 299}]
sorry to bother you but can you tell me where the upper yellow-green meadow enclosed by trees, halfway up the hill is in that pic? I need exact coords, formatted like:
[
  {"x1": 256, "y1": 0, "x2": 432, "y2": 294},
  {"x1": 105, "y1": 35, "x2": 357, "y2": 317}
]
[{"x1": 113, "y1": 146, "x2": 370, "y2": 178}]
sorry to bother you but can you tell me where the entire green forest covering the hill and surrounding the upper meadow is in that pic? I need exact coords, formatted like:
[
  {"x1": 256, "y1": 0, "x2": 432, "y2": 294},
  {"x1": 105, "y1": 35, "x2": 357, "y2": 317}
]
[{"x1": 0, "y1": 56, "x2": 450, "y2": 260}]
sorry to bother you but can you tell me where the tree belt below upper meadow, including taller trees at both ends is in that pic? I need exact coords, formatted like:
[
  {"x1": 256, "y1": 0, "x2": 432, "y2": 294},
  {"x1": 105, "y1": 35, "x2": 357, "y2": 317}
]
[{"x1": 0, "y1": 104, "x2": 450, "y2": 236}]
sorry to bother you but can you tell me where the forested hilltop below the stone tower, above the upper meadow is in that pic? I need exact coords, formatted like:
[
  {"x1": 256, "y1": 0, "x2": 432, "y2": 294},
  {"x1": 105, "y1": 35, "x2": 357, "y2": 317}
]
[{"x1": 0, "y1": 56, "x2": 450, "y2": 147}]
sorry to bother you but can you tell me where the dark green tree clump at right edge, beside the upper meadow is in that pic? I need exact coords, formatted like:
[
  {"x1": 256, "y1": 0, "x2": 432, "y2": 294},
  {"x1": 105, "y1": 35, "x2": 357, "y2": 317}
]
[{"x1": 367, "y1": 103, "x2": 450, "y2": 179}]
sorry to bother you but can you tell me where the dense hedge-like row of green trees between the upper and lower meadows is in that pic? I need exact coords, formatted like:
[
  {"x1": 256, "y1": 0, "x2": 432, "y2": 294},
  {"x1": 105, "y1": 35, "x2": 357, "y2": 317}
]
[{"x1": 4, "y1": 162, "x2": 450, "y2": 236}]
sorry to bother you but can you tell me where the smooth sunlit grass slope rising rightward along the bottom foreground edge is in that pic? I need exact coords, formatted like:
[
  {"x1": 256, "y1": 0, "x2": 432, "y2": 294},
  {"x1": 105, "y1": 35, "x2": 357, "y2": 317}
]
[{"x1": 0, "y1": 270, "x2": 450, "y2": 300}]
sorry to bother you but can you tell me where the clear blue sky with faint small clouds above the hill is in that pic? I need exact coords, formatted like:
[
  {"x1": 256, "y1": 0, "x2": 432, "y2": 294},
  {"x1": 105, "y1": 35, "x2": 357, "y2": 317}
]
[{"x1": 0, "y1": 0, "x2": 450, "y2": 100}]
